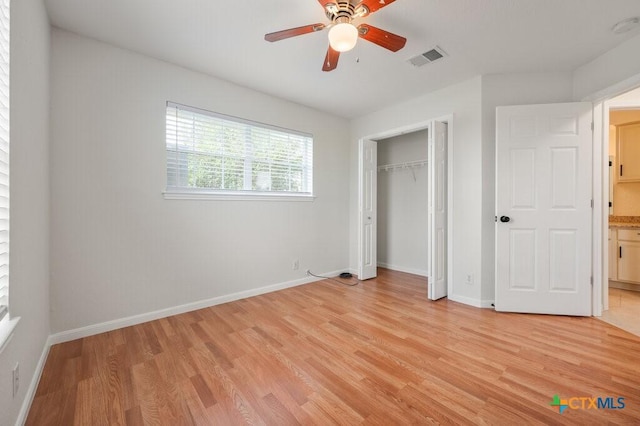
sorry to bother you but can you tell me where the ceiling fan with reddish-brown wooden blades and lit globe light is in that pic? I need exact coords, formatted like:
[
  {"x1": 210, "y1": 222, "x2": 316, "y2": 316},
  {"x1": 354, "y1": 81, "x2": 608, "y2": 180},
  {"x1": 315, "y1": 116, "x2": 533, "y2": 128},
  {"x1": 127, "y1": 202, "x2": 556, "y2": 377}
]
[{"x1": 264, "y1": 0, "x2": 407, "y2": 71}]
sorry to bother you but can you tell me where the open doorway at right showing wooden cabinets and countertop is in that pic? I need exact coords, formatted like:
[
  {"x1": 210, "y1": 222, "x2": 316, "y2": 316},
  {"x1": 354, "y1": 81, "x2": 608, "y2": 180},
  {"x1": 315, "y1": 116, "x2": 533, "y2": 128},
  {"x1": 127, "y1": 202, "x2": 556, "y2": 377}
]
[{"x1": 601, "y1": 88, "x2": 640, "y2": 335}]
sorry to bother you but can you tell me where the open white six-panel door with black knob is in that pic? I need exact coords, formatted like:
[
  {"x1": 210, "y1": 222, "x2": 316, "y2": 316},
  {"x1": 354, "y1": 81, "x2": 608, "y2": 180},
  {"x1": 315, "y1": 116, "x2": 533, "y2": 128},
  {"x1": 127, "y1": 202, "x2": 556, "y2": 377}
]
[{"x1": 495, "y1": 103, "x2": 592, "y2": 315}]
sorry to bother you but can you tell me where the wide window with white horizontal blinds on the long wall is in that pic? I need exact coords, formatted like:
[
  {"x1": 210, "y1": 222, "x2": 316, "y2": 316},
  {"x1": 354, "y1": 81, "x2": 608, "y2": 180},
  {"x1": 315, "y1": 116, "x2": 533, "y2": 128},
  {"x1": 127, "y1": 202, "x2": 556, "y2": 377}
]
[{"x1": 165, "y1": 102, "x2": 313, "y2": 199}]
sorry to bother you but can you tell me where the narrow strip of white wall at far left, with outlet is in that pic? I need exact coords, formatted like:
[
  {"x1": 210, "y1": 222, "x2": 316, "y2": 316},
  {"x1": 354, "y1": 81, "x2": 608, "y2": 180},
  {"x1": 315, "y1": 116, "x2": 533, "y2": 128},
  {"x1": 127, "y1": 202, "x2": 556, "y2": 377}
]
[{"x1": 0, "y1": 0, "x2": 50, "y2": 425}]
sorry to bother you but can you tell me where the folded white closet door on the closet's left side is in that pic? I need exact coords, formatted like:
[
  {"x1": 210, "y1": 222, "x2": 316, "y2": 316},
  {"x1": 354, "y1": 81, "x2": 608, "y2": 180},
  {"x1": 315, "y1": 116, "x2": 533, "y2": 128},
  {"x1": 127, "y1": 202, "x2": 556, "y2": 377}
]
[{"x1": 358, "y1": 139, "x2": 378, "y2": 280}]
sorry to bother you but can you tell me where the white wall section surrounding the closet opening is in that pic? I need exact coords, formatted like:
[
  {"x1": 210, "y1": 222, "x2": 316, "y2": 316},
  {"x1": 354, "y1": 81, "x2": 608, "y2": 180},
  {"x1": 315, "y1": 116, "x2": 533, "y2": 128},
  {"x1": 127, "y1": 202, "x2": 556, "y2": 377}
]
[{"x1": 350, "y1": 77, "x2": 482, "y2": 305}]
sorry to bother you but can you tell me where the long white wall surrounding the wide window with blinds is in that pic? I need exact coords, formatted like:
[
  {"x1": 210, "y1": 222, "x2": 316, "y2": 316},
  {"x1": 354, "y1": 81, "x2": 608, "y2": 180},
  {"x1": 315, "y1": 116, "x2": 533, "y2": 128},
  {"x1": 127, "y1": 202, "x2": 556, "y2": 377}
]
[{"x1": 51, "y1": 29, "x2": 349, "y2": 332}]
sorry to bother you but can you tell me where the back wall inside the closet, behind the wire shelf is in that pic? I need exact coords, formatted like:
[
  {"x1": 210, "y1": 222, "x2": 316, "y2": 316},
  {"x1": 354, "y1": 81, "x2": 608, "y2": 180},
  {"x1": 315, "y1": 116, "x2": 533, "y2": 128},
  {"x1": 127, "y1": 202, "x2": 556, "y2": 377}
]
[{"x1": 378, "y1": 130, "x2": 429, "y2": 276}]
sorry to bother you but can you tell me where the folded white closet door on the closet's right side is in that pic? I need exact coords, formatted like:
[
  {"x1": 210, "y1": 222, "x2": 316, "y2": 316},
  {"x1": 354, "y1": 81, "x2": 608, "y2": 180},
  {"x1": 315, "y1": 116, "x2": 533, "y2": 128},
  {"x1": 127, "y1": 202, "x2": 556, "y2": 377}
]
[{"x1": 427, "y1": 121, "x2": 447, "y2": 300}]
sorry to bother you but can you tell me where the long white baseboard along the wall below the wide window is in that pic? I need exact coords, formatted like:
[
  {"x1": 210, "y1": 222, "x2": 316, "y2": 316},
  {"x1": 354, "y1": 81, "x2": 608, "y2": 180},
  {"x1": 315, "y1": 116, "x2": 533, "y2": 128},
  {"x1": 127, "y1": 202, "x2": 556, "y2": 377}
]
[{"x1": 49, "y1": 269, "x2": 344, "y2": 345}]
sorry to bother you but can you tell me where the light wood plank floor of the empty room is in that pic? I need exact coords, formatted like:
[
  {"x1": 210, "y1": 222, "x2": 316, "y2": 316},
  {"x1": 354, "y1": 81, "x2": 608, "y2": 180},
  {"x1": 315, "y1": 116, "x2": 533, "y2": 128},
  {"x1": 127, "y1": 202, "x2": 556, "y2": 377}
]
[{"x1": 27, "y1": 270, "x2": 640, "y2": 425}]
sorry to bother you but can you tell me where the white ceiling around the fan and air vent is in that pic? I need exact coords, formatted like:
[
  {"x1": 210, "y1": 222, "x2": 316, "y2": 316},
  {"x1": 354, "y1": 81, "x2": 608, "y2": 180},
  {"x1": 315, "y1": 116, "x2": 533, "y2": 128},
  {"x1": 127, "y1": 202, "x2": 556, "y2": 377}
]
[{"x1": 45, "y1": 0, "x2": 640, "y2": 118}]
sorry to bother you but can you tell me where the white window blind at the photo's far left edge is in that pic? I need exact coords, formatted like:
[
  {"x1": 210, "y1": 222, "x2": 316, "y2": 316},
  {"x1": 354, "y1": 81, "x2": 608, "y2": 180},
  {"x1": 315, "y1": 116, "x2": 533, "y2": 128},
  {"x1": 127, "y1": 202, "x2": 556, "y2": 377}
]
[{"x1": 0, "y1": 0, "x2": 10, "y2": 321}]
